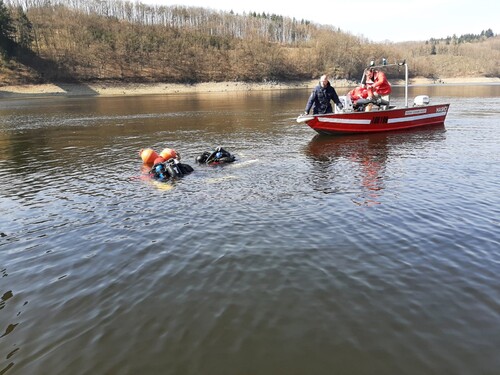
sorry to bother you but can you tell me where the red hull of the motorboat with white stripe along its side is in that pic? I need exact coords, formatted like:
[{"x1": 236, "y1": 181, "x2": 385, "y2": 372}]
[{"x1": 297, "y1": 104, "x2": 450, "y2": 134}]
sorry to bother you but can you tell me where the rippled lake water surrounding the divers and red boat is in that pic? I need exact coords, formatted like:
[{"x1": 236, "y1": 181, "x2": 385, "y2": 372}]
[{"x1": 0, "y1": 85, "x2": 500, "y2": 375}]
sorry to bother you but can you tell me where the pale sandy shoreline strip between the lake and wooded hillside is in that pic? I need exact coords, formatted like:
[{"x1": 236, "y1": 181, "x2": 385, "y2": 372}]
[{"x1": 0, "y1": 77, "x2": 500, "y2": 99}]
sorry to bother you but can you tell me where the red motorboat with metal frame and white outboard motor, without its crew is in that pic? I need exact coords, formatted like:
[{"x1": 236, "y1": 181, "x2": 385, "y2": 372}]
[{"x1": 297, "y1": 61, "x2": 450, "y2": 134}]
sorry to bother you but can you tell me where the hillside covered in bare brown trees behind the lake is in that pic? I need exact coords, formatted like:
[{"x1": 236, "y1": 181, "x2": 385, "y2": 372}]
[{"x1": 0, "y1": 0, "x2": 500, "y2": 85}]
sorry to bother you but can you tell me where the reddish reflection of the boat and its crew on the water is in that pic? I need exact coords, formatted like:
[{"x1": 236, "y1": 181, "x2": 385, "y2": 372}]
[{"x1": 305, "y1": 125, "x2": 445, "y2": 206}]
